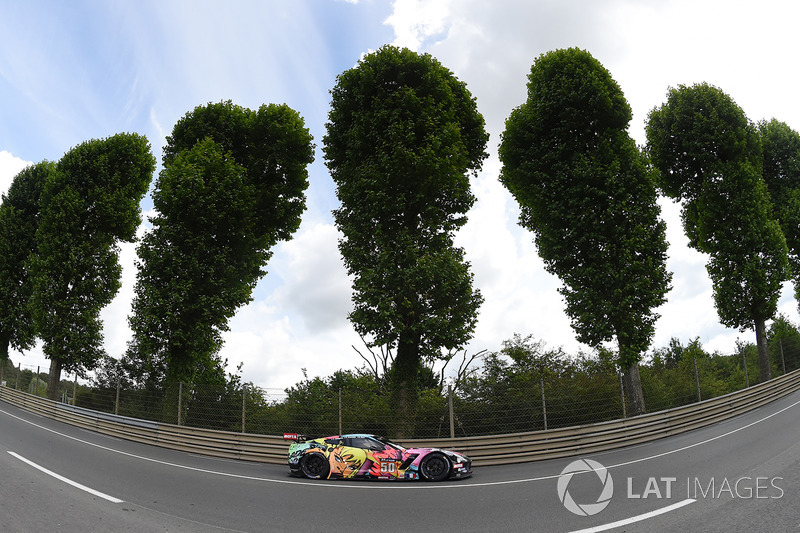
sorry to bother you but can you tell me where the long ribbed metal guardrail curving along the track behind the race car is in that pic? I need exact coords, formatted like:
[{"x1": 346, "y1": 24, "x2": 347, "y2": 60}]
[{"x1": 0, "y1": 370, "x2": 800, "y2": 466}]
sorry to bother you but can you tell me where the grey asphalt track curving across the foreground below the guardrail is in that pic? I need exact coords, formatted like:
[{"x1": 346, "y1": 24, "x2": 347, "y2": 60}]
[{"x1": 0, "y1": 386, "x2": 800, "y2": 533}]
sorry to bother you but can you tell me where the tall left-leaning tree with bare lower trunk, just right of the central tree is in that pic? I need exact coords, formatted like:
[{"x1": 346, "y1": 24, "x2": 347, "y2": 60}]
[{"x1": 500, "y1": 48, "x2": 671, "y2": 414}]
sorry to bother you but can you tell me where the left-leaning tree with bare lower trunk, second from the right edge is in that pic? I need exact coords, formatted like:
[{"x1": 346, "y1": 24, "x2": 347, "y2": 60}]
[{"x1": 646, "y1": 84, "x2": 789, "y2": 381}]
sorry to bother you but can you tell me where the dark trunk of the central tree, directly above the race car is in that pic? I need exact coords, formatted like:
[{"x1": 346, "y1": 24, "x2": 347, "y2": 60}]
[{"x1": 391, "y1": 335, "x2": 420, "y2": 439}]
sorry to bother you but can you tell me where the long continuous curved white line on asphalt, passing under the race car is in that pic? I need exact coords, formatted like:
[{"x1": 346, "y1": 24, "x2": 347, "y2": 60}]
[{"x1": 0, "y1": 392, "x2": 800, "y2": 490}]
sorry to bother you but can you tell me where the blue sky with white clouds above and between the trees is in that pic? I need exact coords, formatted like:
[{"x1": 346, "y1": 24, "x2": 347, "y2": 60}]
[{"x1": 0, "y1": 0, "x2": 800, "y2": 389}]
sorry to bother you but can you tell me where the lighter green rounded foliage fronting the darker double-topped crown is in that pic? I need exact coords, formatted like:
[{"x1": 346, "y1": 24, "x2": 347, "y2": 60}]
[{"x1": 131, "y1": 139, "x2": 256, "y2": 382}]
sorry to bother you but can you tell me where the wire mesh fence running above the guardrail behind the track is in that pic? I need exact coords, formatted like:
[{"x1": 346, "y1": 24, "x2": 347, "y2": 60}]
[{"x1": 3, "y1": 338, "x2": 800, "y2": 438}]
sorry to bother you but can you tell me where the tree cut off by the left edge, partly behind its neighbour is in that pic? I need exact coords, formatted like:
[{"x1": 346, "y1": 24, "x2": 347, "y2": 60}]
[{"x1": 0, "y1": 161, "x2": 55, "y2": 370}]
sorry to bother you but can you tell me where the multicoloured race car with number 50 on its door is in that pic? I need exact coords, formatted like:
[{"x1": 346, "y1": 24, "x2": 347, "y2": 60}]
[{"x1": 283, "y1": 433, "x2": 472, "y2": 481}]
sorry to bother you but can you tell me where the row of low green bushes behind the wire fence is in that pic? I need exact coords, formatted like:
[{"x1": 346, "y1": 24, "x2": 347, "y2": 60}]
[{"x1": 72, "y1": 324, "x2": 800, "y2": 438}]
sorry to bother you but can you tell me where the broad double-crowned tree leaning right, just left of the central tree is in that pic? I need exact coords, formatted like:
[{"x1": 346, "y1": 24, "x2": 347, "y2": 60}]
[{"x1": 128, "y1": 102, "x2": 313, "y2": 385}]
